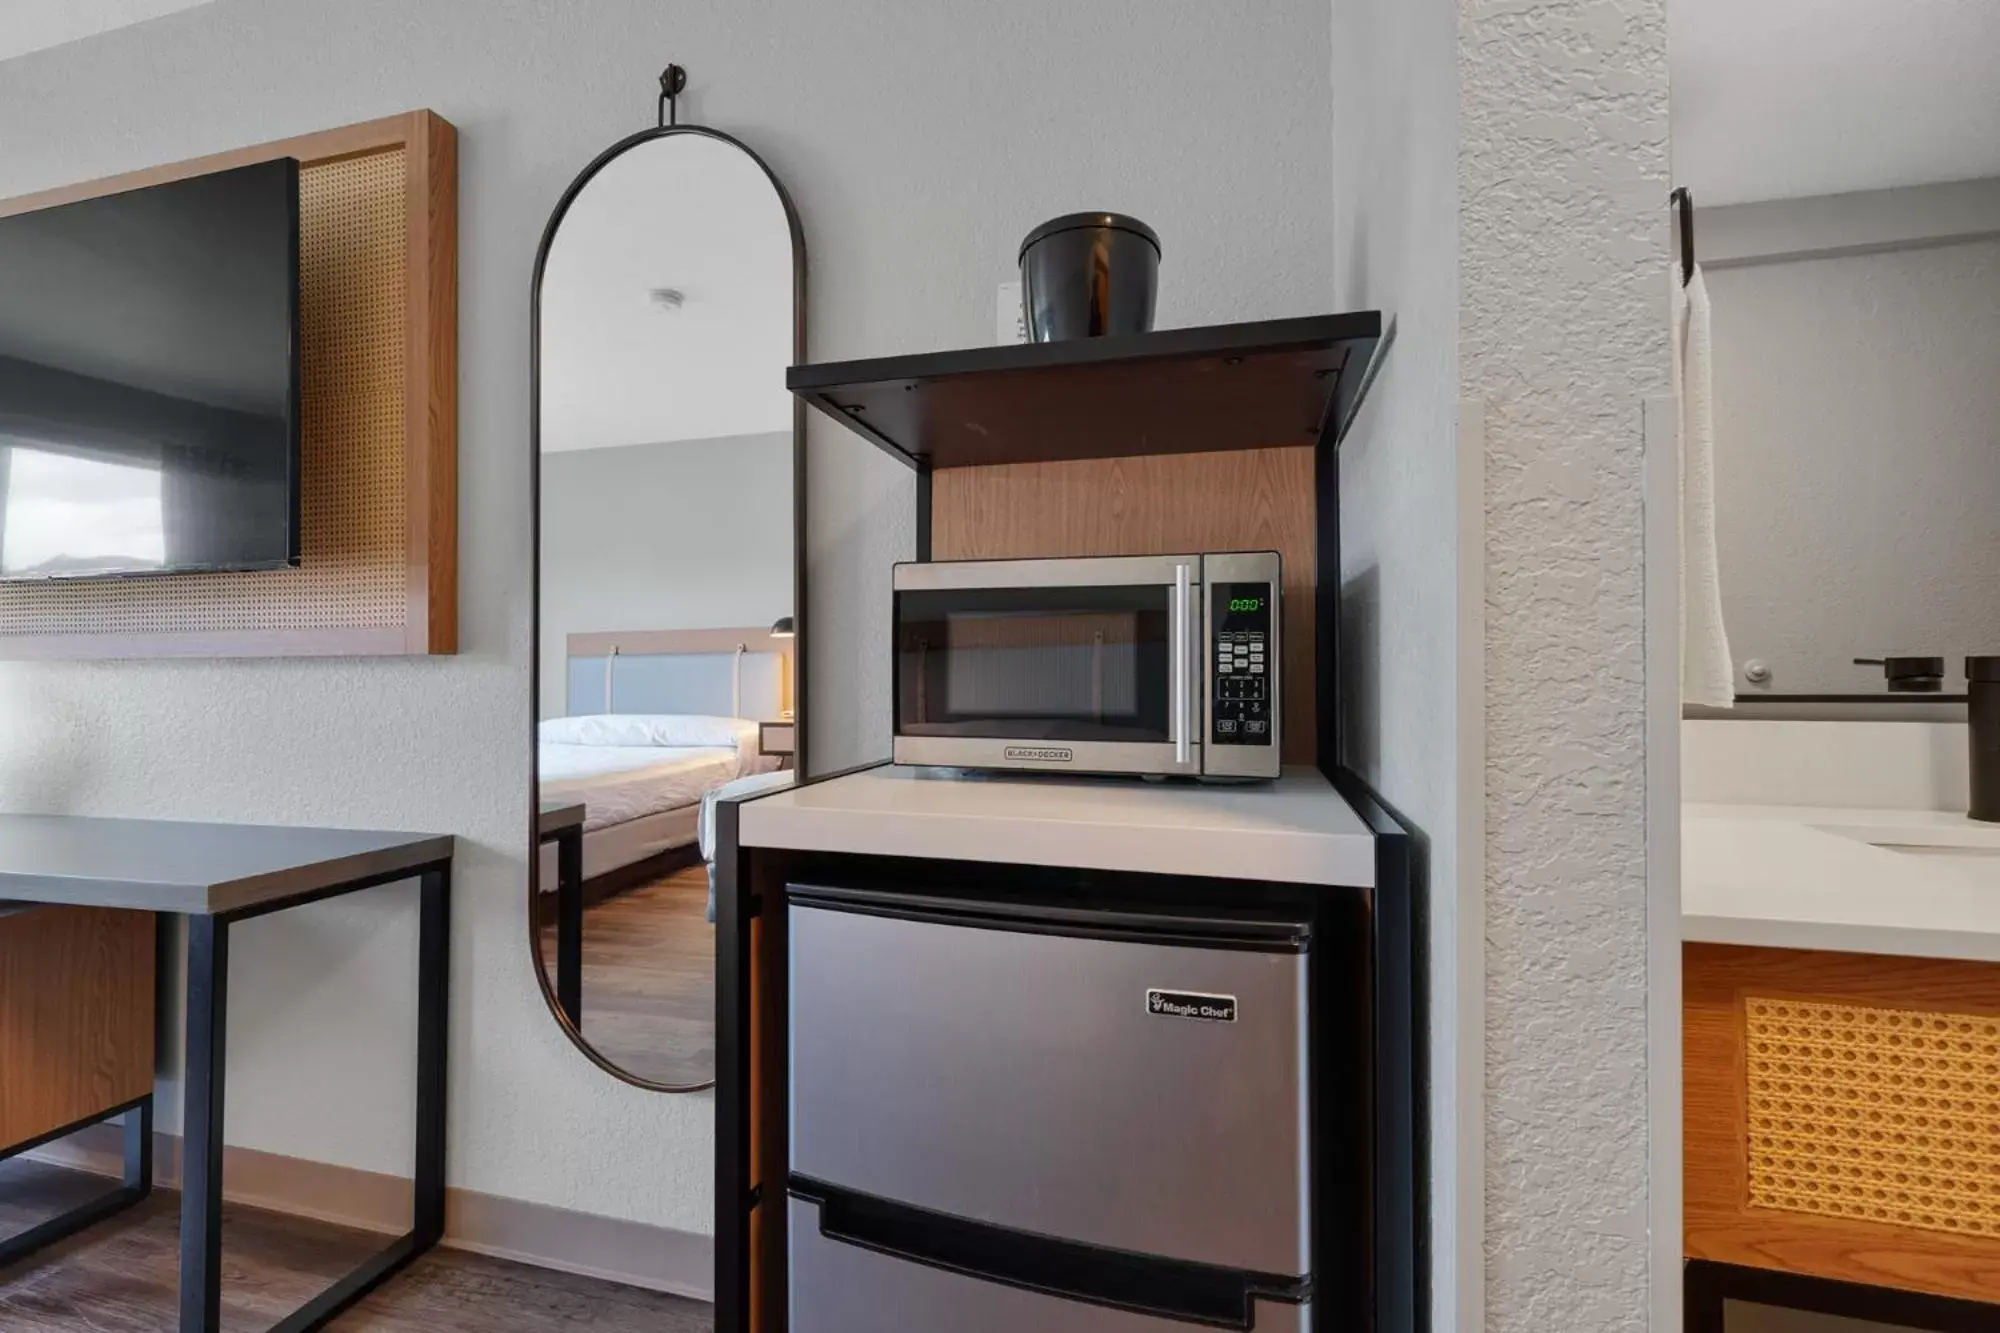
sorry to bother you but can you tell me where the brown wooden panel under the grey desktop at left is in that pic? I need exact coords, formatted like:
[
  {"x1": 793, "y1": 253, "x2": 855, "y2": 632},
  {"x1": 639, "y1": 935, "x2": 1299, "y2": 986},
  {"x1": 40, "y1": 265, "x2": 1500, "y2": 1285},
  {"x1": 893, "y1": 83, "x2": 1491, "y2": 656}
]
[{"x1": 0, "y1": 907, "x2": 154, "y2": 1149}]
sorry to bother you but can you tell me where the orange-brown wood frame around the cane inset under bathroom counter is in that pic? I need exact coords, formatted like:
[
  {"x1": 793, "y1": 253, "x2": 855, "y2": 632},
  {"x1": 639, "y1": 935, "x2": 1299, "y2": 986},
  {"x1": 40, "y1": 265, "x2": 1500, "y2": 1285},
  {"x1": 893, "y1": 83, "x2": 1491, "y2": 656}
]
[{"x1": 1682, "y1": 945, "x2": 2000, "y2": 1303}]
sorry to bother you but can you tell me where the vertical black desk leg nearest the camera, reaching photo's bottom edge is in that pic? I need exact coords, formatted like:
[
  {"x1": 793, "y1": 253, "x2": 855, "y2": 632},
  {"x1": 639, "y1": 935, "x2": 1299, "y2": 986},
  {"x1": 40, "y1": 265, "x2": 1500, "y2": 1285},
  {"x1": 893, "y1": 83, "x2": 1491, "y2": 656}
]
[{"x1": 180, "y1": 917, "x2": 230, "y2": 1333}]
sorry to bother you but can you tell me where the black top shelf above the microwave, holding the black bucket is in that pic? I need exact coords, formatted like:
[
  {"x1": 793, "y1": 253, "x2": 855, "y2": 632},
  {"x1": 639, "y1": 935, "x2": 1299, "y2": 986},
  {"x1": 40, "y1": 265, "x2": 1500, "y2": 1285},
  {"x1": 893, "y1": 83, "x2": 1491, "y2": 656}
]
[{"x1": 786, "y1": 310, "x2": 1382, "y2": 470}]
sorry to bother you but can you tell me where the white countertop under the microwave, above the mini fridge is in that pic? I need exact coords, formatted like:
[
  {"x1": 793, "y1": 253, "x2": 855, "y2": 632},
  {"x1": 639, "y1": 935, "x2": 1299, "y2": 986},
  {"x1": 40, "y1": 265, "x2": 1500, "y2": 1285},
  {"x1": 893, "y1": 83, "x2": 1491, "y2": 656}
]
[{"x1": 738, "y1": 765, "x2": 1376, "y2": 889}]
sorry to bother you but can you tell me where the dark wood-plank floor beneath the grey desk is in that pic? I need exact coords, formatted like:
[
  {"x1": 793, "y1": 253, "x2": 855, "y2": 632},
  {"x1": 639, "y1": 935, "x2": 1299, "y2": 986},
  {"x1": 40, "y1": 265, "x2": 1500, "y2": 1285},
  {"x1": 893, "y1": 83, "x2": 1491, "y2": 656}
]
[{"x1": 0, "y1": 1161, "x2": 714, "y2": 1333}]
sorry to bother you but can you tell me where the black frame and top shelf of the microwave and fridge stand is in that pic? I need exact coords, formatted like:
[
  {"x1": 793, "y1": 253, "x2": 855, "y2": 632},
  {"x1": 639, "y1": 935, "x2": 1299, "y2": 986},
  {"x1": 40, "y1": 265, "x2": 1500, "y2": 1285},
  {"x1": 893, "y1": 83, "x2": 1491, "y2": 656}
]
[{"x1": 744, "y1": 310, "x2": 1428, "y2": 1333}]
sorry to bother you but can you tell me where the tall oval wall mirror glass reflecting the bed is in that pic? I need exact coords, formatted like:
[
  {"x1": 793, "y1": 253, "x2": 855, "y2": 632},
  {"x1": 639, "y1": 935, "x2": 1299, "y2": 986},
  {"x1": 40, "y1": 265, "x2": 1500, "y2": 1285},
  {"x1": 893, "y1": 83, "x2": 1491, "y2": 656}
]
[{"x1": 528, "y1": 126, "x2": 806, "y2": 1091}]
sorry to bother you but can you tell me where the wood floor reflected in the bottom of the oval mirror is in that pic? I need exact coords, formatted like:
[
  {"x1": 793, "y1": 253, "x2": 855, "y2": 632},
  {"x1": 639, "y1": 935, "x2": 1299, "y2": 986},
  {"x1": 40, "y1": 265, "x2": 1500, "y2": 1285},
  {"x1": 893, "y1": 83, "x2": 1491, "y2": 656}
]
[{"x1": 542, "y1": 863, "x2": 716, "y2": 1085}]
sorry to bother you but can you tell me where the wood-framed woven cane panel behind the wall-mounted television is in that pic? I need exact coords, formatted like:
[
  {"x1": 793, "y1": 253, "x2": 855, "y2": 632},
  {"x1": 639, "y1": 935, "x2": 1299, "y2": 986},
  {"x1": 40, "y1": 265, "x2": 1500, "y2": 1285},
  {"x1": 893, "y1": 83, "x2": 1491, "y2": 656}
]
[{"x1": 0, "y1": 112, "x2": 458, "y2": 658}]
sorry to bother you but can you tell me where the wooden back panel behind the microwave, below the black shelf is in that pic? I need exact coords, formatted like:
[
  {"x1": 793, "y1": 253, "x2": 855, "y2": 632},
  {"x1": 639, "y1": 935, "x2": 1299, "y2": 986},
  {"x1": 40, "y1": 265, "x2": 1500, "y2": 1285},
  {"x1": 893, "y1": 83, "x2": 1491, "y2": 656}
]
[{"x1": 930, "y1": 448, "x2": 1316, "y2": 765}]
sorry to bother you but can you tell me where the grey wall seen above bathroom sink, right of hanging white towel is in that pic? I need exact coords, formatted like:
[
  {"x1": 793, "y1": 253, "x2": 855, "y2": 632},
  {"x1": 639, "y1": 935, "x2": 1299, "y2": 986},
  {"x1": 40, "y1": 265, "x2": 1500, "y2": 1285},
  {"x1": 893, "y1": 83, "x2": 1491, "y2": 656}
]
[{"x1": 1708, "y1": 237, "x2": 2000, "y2": 695}]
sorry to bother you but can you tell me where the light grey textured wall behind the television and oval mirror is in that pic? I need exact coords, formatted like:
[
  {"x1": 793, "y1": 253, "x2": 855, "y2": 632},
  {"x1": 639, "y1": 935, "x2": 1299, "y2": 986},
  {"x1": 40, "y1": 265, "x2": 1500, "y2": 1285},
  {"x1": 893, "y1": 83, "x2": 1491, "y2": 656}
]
[{"x1": 0, "y1": 0, "x2": 1332, "y2": 1231}]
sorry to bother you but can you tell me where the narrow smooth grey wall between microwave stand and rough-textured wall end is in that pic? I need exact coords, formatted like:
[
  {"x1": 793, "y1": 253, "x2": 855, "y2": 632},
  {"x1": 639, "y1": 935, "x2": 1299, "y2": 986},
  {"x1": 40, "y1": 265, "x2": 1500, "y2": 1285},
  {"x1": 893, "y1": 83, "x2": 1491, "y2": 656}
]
[{"x1": 1332, "y1": 0, "x2": 1484, "y2": 1329}]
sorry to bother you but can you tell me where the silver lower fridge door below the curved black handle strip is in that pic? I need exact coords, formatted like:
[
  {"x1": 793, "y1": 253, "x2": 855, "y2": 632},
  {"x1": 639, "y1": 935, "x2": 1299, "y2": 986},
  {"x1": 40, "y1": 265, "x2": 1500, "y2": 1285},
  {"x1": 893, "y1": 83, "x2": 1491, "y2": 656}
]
[{"x1": 788, "y1": 1199, "x2": 1312, "y2": 1333}]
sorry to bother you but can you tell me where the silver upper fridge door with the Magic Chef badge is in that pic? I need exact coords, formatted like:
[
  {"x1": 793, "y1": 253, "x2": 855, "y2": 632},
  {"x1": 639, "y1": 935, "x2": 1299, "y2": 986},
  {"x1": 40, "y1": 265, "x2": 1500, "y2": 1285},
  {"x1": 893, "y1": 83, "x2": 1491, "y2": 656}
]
[{"x1": 790, "y1": 895, "x2": 1312, "y2": 1272}]
